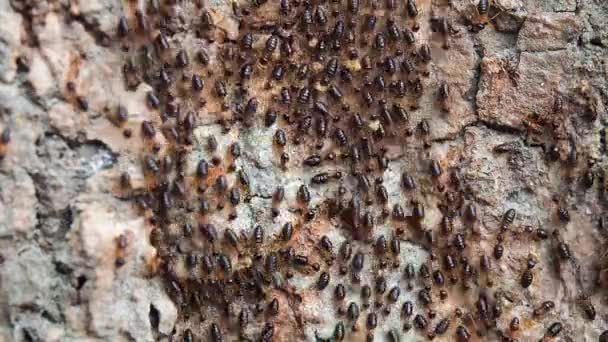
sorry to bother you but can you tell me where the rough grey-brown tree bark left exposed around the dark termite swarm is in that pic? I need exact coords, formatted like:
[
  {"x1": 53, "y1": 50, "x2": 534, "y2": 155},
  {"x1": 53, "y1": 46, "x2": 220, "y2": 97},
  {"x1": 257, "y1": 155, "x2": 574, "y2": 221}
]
[{"x1": 0, "y1": 0, "x2": 608, "y2": 342}]
